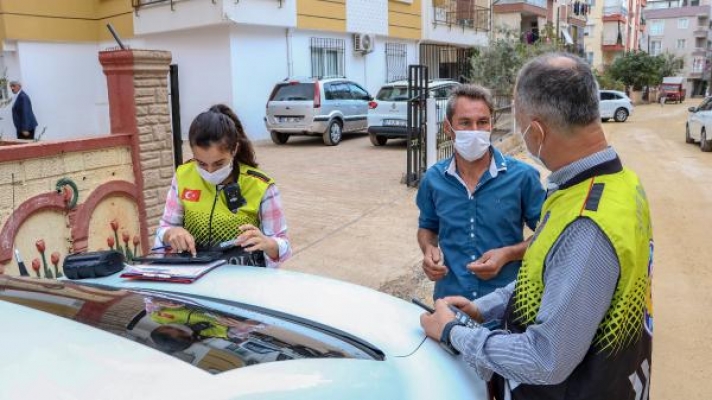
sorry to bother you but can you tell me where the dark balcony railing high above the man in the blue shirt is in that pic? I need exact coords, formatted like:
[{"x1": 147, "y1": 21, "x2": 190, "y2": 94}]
[{"x1": 433, "y1": 0, "x2": 490, "y2": 31}]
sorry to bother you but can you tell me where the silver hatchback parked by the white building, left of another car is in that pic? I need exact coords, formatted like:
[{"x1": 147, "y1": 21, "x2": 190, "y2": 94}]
[{"x1": 265, "y1": 78, "x2": 373, "y2": 146}]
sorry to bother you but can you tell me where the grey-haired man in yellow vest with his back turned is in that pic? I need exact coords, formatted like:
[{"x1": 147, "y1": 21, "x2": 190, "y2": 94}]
[{"x1": 421, "y1": 53, "x2": 653, "y2": 400}]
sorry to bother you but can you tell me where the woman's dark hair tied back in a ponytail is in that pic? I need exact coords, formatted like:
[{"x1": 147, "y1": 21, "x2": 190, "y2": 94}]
[{"x1": 188, "y1": 104, "x2": 258, "y2": 168}]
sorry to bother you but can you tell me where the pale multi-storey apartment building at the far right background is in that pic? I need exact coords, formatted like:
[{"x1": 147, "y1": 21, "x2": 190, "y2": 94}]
[{"x1": 643, "y1": 0, "x2": 712, "y2": 96}]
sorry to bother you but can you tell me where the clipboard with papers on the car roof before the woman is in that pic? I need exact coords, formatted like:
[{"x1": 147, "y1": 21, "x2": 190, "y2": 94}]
[{"x1": 119, "y1": 260, "x2": 226, "y2": 283}]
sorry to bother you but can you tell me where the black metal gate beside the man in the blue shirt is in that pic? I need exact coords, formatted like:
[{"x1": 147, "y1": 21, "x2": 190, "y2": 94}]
[{"x1": 405, "y1": 65, "x2": 428, "y2": 187}]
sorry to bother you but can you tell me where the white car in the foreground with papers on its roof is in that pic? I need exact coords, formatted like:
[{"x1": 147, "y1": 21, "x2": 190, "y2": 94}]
[{"x1": 0, "y1": 265, "x2": 487, "y2": 400}]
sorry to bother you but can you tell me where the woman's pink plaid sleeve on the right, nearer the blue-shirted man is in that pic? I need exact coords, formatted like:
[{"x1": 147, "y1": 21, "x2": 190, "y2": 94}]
[{"x1": 258, "y1": 185, "x2": 292, "y2": 268}]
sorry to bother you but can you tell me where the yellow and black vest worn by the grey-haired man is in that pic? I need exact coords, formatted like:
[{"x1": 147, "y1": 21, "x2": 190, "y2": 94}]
[{"x1": 500, "y1": 168, "x2": 653, "y2": 400}]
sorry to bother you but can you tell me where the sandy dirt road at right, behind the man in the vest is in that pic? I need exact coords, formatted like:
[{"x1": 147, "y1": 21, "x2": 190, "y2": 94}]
[{"x1": 604, "y1": 99, "x2": 712, "y2": 400}]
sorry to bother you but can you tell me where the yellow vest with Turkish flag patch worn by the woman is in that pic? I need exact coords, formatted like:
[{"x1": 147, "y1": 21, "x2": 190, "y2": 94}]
[{"x1": 176, "y1": 162, "x2": 274, "y2": 248}]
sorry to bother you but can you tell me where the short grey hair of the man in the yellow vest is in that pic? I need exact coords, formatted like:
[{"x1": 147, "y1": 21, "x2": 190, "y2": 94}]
[{"x1": 514, "y1": 52, "x2": 601, "y2": 133}]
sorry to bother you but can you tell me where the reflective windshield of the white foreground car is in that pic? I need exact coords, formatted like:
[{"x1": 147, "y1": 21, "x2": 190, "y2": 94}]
[{"x1": 0, "y1": 277, "x2": 382, "y2": 374}]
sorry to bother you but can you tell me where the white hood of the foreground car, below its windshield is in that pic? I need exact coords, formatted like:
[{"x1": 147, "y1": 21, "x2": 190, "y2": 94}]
[{"x1": 0, "y1": 301, "x2": 472, "y2": 400}]
